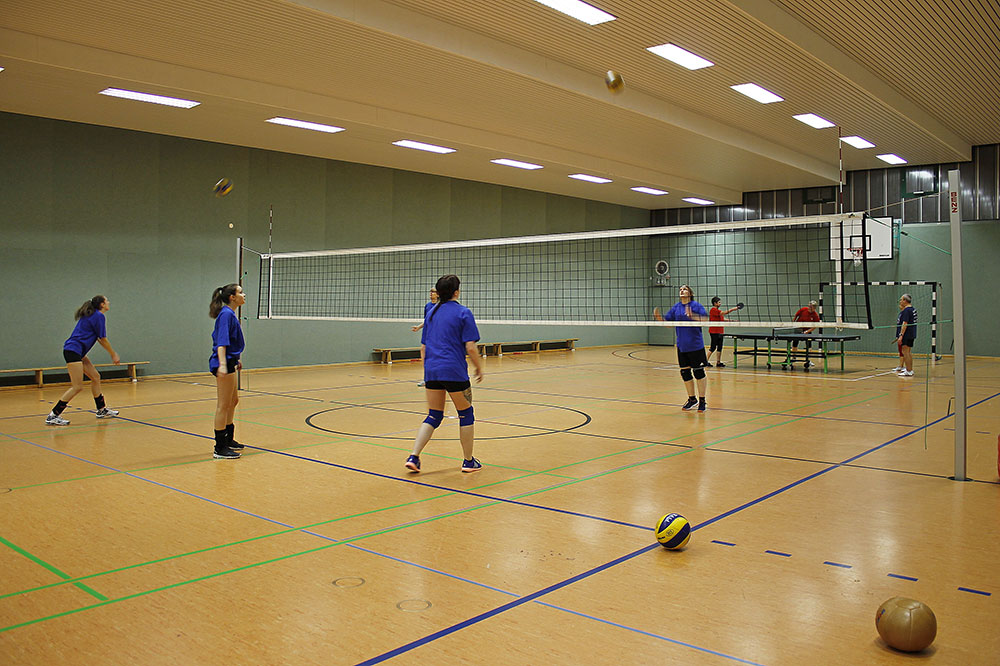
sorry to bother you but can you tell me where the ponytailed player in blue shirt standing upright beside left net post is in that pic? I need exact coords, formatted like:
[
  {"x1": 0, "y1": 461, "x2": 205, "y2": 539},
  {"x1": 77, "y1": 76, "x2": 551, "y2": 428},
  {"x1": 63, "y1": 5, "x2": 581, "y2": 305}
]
[{"x1": 208, "y1": 283, "x2": 247, "y2": 460}]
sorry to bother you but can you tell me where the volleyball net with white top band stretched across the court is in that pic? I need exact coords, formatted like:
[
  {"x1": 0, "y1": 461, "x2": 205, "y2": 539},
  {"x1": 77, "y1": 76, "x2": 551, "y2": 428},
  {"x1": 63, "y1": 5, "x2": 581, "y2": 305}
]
[{"x1": 257, "y1": 213, "x2": 871, "y2": 328}]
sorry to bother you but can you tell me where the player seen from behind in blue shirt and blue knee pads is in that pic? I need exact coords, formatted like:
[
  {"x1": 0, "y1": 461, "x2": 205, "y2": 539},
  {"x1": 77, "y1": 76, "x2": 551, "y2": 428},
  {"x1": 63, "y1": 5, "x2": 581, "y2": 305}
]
[{"x1": 406, "y1": 275, "x2": 483, "y2": 472}]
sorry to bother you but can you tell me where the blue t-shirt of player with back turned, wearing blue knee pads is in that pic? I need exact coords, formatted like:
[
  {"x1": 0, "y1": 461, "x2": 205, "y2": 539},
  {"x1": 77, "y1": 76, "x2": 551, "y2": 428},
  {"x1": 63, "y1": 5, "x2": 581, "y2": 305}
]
[{"x1": 420, "y1": 301, "x2": 479, "y2": 382}]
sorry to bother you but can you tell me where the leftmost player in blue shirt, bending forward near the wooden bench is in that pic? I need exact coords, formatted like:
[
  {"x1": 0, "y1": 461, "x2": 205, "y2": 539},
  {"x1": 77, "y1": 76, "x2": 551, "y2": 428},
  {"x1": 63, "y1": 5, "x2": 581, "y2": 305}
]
[{"x1": 45, "y1": 295, "x2": 121, "y2": 425}]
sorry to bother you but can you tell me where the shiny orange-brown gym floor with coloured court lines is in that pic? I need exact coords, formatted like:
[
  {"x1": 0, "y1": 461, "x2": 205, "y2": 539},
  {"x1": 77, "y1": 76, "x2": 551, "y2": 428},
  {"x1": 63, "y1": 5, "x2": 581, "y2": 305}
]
[{"x1": 0, "y1": 346, "x2": 1000, "y2": 665}]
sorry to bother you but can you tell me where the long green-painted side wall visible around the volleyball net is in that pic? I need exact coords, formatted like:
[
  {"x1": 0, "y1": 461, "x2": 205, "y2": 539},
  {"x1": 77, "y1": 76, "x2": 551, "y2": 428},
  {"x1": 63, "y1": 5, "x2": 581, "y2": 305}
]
[{"x1": 0, "y1": 113, "x2": 649, "y2": 374}]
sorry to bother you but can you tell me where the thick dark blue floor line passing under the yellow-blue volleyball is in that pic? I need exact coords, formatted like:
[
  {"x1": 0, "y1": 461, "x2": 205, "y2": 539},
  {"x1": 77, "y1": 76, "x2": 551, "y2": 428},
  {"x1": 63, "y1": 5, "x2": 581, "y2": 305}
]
[{"x1": 358, "y1": 386, "x2": 1000, "y2": 666}]
